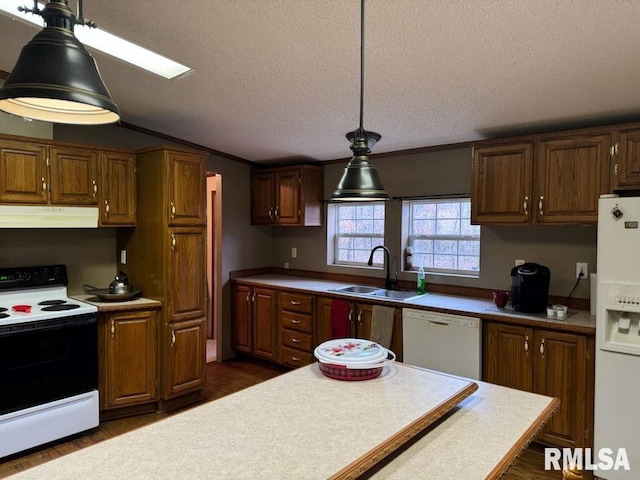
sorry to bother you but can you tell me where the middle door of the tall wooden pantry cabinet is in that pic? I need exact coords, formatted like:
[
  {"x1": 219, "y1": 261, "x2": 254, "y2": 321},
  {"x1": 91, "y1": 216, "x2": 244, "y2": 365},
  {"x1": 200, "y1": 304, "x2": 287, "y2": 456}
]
[{"x1": 168, "y1": 228, "x2": 206, "y2": 321}]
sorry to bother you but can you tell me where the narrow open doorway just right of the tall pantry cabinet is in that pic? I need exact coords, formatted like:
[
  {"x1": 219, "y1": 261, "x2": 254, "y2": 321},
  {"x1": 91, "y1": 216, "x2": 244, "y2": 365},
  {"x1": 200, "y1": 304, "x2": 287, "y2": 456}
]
[{"x1": 207, "y1": 172, "x2": 222, "y2": 363}]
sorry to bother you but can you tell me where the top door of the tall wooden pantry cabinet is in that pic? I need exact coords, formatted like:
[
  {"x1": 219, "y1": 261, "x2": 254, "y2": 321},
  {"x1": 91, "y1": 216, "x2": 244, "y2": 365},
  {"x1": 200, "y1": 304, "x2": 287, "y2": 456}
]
[{"x1": 166, "y1": 150, "x2": 206, "y2": 226}]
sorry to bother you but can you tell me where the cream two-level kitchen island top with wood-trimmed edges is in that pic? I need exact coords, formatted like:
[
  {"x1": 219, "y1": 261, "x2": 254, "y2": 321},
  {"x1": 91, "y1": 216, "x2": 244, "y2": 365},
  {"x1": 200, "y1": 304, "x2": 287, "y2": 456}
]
[{"x1": 5, "y1": 363, "x2": 558, "y2": 480}]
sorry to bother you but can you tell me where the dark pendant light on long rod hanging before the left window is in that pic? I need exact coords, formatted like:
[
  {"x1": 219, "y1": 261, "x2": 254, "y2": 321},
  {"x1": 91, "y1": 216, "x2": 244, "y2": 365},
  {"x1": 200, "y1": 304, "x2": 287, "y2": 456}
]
[{"x1": 331, "y1": 0, "x2": 389, "y2": 202}]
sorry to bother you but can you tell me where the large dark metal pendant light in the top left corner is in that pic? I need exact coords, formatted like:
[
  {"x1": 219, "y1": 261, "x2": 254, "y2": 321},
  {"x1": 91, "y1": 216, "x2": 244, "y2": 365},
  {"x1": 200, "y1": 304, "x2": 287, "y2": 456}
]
[{"x1": 0, "y1": 0, "x2": 120, "y2": 125}]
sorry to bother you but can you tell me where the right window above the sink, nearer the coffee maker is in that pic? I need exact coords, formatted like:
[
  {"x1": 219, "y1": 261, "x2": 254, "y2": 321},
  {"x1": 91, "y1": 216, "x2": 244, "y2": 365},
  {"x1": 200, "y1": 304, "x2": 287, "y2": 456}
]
[{"x1": 403, "y1": 198, "x2": 480, "y2": 275}]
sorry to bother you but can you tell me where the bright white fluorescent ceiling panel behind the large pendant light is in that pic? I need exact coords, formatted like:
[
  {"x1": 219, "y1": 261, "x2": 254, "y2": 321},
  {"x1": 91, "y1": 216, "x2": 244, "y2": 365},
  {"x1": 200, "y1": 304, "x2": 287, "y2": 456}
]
[{"x1": 0, "y1": 0, "x2": 191, "y2": 79}]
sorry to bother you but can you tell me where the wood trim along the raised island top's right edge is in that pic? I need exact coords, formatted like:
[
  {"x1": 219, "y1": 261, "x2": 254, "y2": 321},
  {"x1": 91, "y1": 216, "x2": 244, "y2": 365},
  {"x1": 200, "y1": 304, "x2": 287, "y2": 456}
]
[{"x1": 329, "y1": 376, "x2": 478, "y2": 480}]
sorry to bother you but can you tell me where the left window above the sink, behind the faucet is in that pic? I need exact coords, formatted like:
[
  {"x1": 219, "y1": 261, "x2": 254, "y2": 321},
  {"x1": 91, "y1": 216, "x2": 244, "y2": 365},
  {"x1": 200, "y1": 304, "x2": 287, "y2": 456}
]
[{"x1": 328, "y1": 202, "x2": 385, "y2": 266}]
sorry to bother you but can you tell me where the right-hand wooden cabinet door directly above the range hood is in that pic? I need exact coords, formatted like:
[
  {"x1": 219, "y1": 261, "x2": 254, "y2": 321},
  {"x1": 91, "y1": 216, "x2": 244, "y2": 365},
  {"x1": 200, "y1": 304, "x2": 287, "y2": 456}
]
[{"x1": 49, "y1": 147, "x2": 98, "y2": 205}]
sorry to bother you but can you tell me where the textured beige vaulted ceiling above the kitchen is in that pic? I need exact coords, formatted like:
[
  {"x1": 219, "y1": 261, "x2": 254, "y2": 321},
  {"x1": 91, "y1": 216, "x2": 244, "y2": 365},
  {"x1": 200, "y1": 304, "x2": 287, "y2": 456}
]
[{"x1": 0, "y1": 0, "x2": 640, "y2": 162}]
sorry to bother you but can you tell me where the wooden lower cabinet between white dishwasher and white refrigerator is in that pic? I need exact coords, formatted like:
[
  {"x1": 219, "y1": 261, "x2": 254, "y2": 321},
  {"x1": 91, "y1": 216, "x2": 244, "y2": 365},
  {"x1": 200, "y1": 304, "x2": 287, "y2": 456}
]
[{"x1": 483, "y1": 321, "x2": 594, "y2": 448}]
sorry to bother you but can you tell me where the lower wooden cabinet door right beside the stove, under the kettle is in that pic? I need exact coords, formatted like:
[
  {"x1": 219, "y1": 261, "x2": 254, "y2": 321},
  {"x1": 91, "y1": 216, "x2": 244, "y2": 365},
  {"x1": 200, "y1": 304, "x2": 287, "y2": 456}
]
[{"x1": 100, "y1": 310, "x2": 158, "y2": 409}]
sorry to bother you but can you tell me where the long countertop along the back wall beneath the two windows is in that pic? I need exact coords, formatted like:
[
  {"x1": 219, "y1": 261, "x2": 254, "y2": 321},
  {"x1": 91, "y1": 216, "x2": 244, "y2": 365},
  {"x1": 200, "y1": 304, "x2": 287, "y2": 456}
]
[{"x1": 235, "y1": 274, "x2": 596, "y2": 334}]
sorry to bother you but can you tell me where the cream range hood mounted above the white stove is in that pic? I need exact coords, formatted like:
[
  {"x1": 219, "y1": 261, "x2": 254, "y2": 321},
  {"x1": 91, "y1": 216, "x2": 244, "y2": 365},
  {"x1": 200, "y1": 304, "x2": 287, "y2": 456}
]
[{"x1": 0, "y1": 205, "x2": 99, "y2": 228}]
